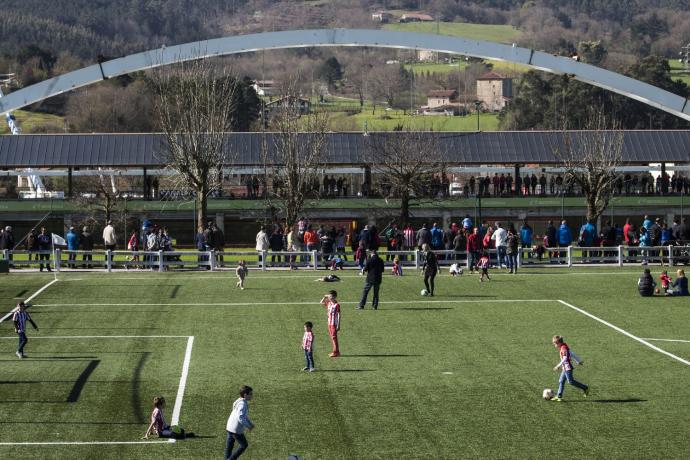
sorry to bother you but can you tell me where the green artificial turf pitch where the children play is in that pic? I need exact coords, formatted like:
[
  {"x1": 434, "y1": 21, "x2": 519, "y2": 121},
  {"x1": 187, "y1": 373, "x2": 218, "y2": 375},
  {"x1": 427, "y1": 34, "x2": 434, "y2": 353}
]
[{"x1": 0, "y1": 267, "x2": 690, "y2": 459}]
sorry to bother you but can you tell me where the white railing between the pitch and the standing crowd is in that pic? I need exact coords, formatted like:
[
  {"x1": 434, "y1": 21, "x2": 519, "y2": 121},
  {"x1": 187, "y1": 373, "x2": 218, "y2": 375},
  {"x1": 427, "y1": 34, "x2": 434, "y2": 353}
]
[{"x1": 0, "y1": 244, "x2": 690, "y2": 272}]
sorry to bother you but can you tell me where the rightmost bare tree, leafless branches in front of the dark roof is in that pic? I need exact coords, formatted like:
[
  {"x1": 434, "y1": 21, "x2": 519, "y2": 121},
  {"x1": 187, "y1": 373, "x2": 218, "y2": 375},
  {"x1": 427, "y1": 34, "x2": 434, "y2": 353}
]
[{"x1": 551, "y1": 111, "x2": 624, "y2": 222}]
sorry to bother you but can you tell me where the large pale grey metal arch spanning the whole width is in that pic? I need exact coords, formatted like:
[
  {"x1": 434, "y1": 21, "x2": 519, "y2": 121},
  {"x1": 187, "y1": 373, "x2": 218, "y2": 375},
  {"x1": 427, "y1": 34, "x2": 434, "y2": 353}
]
[{"x1": 0, "y1": 29, "x2": 690, "y2": 121}]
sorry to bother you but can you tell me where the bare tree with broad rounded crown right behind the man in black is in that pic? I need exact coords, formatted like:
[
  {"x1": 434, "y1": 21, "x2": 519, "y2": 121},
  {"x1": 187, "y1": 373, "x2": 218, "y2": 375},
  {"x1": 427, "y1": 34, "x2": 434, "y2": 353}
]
[{"x1": 368, "y1": 127, "x2": 445, "y2": 223}]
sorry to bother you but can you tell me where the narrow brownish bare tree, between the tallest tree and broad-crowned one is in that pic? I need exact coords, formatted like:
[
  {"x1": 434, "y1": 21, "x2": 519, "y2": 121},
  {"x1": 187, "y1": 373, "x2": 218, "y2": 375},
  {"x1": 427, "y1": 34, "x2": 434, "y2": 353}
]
[{"x1": 262, "y1": 78, "x2": 328, "y2": 227}]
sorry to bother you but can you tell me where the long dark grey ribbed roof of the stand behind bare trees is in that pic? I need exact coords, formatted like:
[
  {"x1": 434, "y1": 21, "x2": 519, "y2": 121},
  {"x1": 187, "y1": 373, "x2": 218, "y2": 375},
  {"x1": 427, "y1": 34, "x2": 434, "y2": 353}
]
[{"x1": 0, "y1": 130, "x2": 690, "y2": 169}]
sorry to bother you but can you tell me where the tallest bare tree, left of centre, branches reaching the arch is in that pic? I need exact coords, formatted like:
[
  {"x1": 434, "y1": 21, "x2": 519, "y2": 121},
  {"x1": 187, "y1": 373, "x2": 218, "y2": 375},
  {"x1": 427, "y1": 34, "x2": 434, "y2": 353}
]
[{"x1": 152, "y1": 60, "x2": 237, "y2": 230}]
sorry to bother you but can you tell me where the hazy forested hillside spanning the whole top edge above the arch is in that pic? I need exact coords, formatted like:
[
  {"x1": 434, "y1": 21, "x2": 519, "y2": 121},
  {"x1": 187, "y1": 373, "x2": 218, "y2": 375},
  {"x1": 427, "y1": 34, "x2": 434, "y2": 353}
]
[{"x1": 0, "y1": 0, "x2": 690, "y2": 61}]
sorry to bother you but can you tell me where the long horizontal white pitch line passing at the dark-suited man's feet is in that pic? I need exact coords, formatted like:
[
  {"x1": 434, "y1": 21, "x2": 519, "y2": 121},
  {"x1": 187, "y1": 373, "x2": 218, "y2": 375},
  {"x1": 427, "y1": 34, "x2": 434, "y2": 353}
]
[{"x1": 34, "y1": 299, "x2": 555, "y2": 308}]
